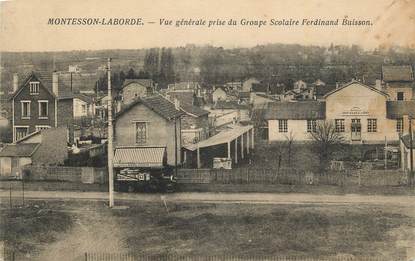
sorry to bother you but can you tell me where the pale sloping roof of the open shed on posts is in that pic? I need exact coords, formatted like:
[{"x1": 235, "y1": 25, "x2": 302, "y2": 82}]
[{"x1": 184, "y1": 125, "x2": 253, "y2": 151}]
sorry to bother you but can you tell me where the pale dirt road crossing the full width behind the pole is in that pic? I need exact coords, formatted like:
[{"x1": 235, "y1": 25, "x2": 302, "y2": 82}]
[{"x1": 0, "y1": 190, "x2": 415, "y2": 207}]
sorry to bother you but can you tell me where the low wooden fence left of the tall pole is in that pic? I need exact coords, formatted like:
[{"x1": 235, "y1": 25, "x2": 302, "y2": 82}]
[{"x1": 23, "y1": 165, "x2": 108, "y2": 184}]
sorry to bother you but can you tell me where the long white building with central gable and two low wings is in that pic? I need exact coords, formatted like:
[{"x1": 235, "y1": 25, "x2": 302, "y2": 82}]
[{"x1": 265, "y1": 81, "x2": 415, "y2": 144}]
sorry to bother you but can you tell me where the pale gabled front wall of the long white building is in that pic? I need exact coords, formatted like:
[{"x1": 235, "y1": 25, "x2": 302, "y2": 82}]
[{"x1": 326, "y1": 83, "x2": 399, "y2": 143}]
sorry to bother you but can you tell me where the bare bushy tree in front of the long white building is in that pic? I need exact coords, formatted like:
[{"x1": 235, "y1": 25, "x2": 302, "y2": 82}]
[{"x1": 310, "y1": 121, "x2": 345, "y2": 171}]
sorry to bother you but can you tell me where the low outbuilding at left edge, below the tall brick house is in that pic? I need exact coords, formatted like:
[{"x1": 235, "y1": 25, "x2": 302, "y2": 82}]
[{"x1": 0, "y1": 128, "x2": 68, "y2": 176}]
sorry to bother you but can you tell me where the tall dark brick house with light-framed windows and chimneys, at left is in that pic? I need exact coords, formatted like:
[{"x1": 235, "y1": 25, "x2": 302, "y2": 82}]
[{"x1": 11, "y1": 72, "x2": 73, "y2": 141}]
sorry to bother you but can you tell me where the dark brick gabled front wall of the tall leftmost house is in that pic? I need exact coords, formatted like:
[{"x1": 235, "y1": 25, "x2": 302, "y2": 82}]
[{"x1": 14, "y1": 77, "x2": 55, "y2": 133}]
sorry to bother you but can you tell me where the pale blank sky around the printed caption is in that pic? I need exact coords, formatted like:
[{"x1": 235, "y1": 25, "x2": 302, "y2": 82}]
[{"x1": 0, "y1": 0, "x2": 415, "y2": 51}]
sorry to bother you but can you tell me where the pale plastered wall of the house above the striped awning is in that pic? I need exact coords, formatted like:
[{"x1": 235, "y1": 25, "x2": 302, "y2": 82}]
[{"x1": 114, "y1": 104, "x2": 181, "y2": 165}]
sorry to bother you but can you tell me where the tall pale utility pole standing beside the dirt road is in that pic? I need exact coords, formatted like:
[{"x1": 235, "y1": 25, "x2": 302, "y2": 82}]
[{"x1": 107, "y1": 58, "x2": 114, "y2": 208}]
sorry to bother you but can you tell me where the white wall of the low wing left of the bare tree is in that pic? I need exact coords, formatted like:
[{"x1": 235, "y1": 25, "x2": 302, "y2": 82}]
[{"x1": 268, "y1": 120, "x2": 311, "y2": 141}]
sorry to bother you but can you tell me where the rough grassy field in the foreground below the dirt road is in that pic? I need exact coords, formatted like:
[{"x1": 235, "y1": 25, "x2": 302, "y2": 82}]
[{"x1": 0, "y1": 198, "x2": 415, "y2": 261}]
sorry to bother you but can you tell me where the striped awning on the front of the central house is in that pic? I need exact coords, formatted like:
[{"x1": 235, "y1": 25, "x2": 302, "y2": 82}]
[{"x1": 113, "y1": 147, "x2": 166, "y2": 168}]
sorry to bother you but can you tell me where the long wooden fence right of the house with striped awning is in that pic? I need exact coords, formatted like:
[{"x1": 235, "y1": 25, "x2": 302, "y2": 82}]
[{"x1": 177, "y1": 168, "x2": 406, "y2": 186}]
